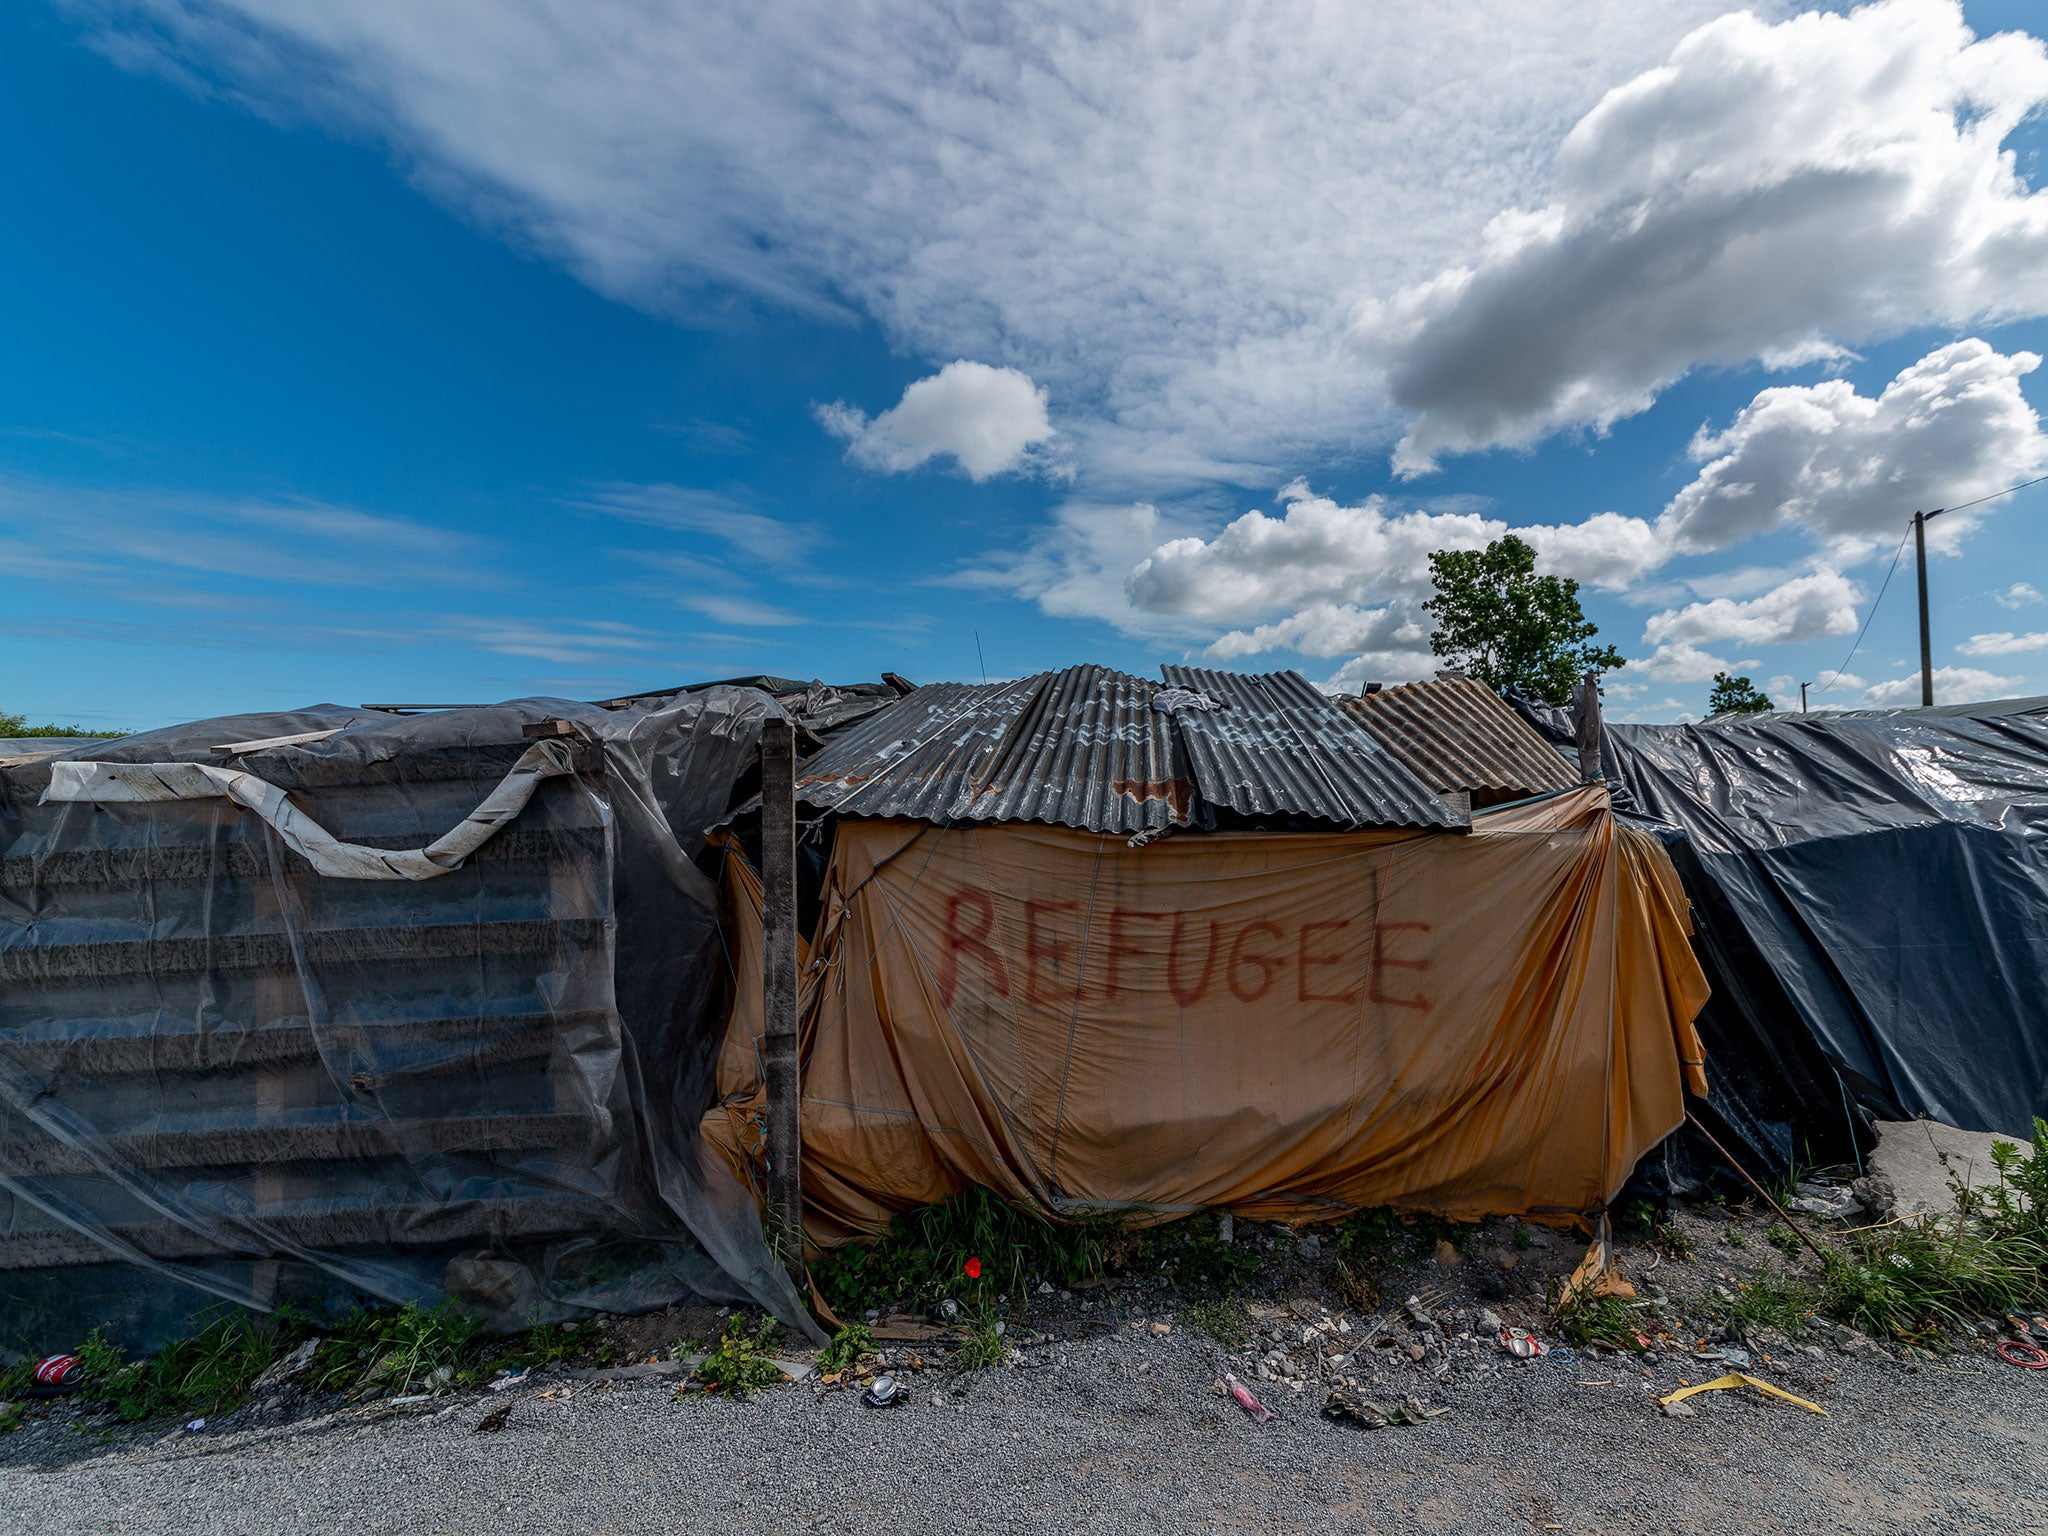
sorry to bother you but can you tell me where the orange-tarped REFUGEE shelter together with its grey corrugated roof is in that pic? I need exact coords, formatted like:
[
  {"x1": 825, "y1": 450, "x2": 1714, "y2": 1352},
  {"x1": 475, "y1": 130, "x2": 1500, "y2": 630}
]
[{"x1": 705, "y1": 668, "x2": 1704, "y2": 1249}]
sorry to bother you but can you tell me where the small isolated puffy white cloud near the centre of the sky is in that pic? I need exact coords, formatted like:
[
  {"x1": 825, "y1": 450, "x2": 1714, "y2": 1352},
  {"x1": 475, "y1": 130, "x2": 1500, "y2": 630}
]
[{"x1": 817, "y1": 358, "x2": 1053, "y2": 479}]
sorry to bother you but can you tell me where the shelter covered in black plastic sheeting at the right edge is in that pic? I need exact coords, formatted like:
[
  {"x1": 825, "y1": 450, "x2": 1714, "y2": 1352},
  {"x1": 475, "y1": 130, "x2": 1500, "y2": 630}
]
[{"x1": 1548, "y1": 698, "x2": 2048, "y2": 1161}]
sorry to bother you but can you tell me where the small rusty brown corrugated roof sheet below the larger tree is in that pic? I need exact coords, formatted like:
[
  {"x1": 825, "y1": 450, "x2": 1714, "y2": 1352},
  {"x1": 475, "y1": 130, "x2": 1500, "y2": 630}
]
[{"x1": 1337, "y1": 676, "x2": 1579, "y2": 805}]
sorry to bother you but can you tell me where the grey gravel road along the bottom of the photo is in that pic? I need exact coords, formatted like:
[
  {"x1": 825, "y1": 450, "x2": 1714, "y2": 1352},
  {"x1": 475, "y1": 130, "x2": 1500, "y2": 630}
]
[{"x1": 0, "y1": 1323, "x2": 2048, "y2": 1536}]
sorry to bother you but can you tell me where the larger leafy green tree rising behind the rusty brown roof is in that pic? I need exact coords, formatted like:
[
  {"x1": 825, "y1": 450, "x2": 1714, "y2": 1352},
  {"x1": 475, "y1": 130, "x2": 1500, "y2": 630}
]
[{"x1": 1423, "y1": 532, "x2": 1626, "y2": 705}]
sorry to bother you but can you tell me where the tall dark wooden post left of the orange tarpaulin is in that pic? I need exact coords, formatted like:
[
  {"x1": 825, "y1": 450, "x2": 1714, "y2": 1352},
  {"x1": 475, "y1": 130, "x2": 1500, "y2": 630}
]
[{"x1": 762, "y1": 719, "x2": 803, "y2": 1274}]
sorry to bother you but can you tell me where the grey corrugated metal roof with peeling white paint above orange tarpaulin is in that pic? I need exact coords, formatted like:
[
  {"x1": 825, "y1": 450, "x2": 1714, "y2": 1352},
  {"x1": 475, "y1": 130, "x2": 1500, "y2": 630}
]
[{"x1": 797, "y1": 666, "x2": 1466, "y2": 836}]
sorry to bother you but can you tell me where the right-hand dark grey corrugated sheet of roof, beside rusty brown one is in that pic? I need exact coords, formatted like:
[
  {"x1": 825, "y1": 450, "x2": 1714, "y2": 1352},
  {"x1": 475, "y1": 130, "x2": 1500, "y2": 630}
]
[{"x1": 1159, "y1": 666, "x2": 1468, "y2": 827}]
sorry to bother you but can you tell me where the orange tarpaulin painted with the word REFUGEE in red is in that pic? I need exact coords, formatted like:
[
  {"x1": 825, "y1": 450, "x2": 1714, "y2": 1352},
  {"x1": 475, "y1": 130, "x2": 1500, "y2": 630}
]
[{"x1": 705, "y1": 786, "x2": 1706, "y2": 1249}]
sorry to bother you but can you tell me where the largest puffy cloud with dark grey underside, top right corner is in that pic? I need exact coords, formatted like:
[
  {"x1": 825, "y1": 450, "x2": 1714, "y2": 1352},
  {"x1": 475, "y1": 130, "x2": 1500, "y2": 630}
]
[{"x1": 1356, "y1": 0, "x2": 2048, "y2": 473}]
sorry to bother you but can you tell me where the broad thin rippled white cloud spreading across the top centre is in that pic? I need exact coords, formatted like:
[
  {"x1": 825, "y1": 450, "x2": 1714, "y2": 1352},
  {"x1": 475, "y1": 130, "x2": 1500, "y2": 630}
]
[{"x1": 80, "y1": 0, "x2": 1744, "y2": 498}]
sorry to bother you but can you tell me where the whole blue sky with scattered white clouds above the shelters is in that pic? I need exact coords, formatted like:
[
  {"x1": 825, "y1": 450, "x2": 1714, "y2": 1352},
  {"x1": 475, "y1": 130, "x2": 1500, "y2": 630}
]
[{"x1": 0, "y1": 0, "x2": 2048, "y2": 729}]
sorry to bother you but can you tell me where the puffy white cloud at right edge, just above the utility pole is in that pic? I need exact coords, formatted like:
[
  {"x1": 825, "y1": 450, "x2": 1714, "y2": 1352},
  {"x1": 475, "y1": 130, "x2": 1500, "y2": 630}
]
[{"x1": 1659, "y1": 339, "x2": 2048, "y2": 559}]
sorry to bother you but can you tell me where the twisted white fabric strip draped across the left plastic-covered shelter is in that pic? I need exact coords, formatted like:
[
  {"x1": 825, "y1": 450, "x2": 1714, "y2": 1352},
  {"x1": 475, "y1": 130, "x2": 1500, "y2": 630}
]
[{"x1": 43, "y1": 741, "x2": 573, "y2": 881}]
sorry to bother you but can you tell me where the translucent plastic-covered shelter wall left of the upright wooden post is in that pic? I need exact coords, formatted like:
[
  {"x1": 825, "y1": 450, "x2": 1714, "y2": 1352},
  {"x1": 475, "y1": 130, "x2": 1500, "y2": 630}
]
[{"x1": 0, "y1": 688, "x2": 809, "y2": 1351}]
